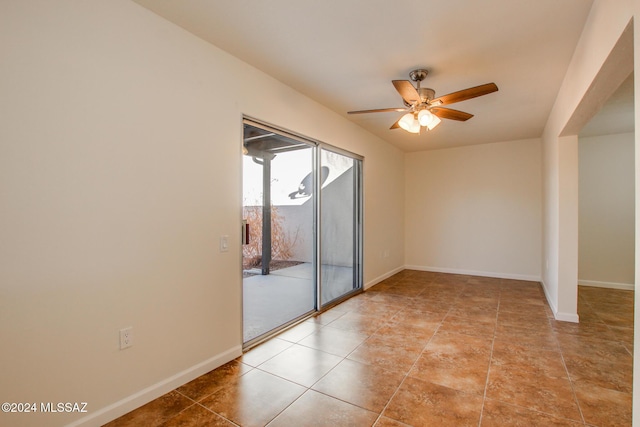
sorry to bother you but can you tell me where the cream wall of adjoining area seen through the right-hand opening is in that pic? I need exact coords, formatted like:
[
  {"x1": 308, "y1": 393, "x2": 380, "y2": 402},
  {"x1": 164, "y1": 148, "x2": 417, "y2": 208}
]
[{"x1": 578, "y1": 133, "x2": 635, "y2": 289}]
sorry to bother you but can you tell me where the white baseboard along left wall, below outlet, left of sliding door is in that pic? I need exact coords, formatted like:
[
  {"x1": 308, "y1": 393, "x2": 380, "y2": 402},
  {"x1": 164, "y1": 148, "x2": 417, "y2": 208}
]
[{"x1": 67, "y1": 346, "x2": 242, "y2": 427}]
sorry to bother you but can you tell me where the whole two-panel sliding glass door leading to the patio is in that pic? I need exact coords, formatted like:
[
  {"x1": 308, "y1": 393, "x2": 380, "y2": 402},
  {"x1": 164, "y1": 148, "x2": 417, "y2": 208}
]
[{"x1": 242, "y1": 119, "x2": 362, "y2": 347}]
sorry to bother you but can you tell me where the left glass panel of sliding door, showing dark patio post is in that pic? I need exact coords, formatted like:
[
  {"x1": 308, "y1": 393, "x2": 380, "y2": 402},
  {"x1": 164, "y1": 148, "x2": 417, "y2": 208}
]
[{"x1": 242, "y1": 123, "x2": 317, "y2": 345}]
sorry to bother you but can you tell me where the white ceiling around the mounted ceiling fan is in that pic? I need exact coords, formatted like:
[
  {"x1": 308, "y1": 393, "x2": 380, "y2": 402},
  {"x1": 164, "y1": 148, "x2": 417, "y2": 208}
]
[{"x1": 134, "y1": 0, "x2": 632, "y2": 151}]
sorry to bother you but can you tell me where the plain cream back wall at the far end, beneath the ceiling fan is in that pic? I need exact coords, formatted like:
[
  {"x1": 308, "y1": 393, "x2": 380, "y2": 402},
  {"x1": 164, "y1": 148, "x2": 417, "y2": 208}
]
[{"x1": 405, "y1": 139, "x2": 541, "y2": 280}]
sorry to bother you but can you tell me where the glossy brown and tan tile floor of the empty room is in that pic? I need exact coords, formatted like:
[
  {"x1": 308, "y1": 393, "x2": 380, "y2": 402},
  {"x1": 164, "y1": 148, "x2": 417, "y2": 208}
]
[{"x1": 107, "y1": 270, "x2": 633, "y2": 427}]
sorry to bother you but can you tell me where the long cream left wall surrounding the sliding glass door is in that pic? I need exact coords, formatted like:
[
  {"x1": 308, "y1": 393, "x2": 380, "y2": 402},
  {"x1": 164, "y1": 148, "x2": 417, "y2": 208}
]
[{"x1": 0, "y1": 0, "x2": 404, "y2": 426}]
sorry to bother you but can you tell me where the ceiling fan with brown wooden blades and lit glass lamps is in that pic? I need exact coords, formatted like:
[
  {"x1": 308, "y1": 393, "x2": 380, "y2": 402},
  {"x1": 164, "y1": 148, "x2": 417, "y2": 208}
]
[{"x1": 347, "y1": 69, "x2": 498, "y2": 133}]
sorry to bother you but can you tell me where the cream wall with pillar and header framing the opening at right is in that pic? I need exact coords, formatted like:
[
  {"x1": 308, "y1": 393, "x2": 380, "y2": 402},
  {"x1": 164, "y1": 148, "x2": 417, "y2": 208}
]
[{"x1": 542, "y1": 0, "x2": 633, "y2": 321}]
